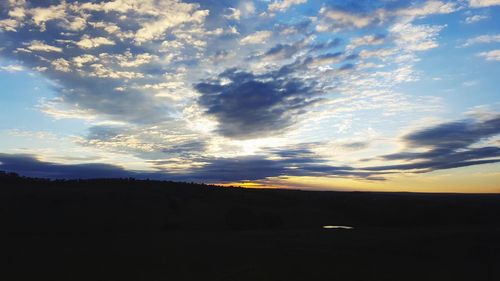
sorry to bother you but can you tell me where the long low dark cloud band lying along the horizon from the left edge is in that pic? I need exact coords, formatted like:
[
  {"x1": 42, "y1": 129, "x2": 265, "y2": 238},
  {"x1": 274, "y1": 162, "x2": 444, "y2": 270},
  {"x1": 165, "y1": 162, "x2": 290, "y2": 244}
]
[{"x1": 0, "y1": 151, "x2": 386, "y2": 183}]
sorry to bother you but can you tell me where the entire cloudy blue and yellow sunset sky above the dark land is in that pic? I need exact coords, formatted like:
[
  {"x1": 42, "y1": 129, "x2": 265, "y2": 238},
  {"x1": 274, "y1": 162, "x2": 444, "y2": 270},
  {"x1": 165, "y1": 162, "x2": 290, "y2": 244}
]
[{"x1": 0, "y1": 0, "x2": 500, "y2": 193}]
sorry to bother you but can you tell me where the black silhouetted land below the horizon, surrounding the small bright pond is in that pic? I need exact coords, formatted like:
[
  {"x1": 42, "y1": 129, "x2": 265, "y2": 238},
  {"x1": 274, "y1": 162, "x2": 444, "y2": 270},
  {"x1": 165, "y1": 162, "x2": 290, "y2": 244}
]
[{"x1": 0, "y1": 174, "x2": 500, "y2": 281}]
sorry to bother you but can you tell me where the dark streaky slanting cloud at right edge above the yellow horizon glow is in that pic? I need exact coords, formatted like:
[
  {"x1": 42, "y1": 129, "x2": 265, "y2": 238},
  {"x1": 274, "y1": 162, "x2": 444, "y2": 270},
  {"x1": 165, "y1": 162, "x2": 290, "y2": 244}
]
[{"x1": 364, "y1": 116, "x2": 500, "y2": 171}]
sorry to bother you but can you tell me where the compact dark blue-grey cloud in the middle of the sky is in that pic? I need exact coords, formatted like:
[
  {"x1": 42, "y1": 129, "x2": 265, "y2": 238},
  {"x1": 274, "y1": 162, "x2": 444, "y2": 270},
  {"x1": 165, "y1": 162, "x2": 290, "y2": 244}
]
[{"x1": 195, "y1": 69, "x2": 318, "y2": 139}]
